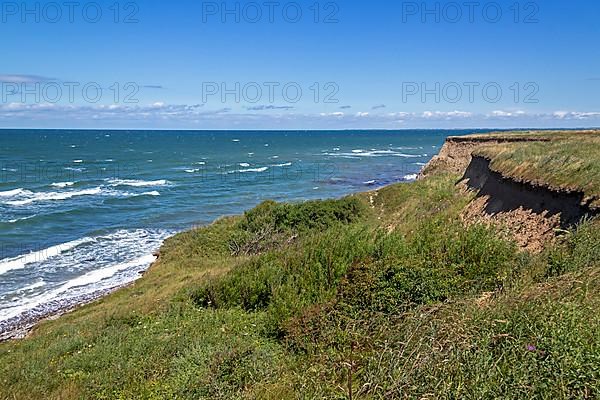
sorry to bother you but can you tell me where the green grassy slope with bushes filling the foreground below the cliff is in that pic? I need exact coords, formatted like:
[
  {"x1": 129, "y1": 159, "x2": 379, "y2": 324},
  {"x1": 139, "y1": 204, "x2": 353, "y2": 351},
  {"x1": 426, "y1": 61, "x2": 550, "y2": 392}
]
[{"x1": 0, "y1": 133, "x2": 600, "y2": 399}]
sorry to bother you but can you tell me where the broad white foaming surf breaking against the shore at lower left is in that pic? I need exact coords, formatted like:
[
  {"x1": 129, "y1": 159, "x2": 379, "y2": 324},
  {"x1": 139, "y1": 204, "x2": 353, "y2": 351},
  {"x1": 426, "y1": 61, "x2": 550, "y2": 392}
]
[{"x1": 0, "y1": 229, "x2": 172, "y2": 324}]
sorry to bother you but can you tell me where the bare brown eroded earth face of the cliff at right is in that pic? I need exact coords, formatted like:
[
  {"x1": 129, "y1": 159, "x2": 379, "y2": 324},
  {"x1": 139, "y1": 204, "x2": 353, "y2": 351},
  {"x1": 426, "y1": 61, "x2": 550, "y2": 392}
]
[{"x1": 419, "y1": 137, "x2": 600, "y2": 252}]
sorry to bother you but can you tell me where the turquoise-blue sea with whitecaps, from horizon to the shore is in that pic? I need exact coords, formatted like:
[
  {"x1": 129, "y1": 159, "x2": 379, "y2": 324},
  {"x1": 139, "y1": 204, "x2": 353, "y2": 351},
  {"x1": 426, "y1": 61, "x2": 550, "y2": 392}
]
[{"x1": 0, "y1": 130, "x2": 480, "y2": 332}]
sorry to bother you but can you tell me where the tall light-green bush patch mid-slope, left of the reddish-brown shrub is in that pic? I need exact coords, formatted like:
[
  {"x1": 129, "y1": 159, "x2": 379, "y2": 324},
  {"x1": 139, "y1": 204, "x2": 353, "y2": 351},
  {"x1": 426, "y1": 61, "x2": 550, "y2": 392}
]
[{"x1": 192, "y1": 224, "x2": 374, "y2": 335}]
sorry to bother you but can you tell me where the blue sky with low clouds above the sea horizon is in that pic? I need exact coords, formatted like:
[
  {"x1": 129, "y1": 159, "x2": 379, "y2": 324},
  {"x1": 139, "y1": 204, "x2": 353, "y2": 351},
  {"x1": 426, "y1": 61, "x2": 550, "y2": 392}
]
[{"x1": 0, "y1": 0, "x2": 600, "y2": 129}]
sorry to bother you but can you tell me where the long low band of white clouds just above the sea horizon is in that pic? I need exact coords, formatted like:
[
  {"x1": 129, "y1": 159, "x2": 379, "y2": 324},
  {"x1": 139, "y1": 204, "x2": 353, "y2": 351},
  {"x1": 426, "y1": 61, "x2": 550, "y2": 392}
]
[{"x1": 0, "y1": 102, "x2": 600, "y2": 129}]
